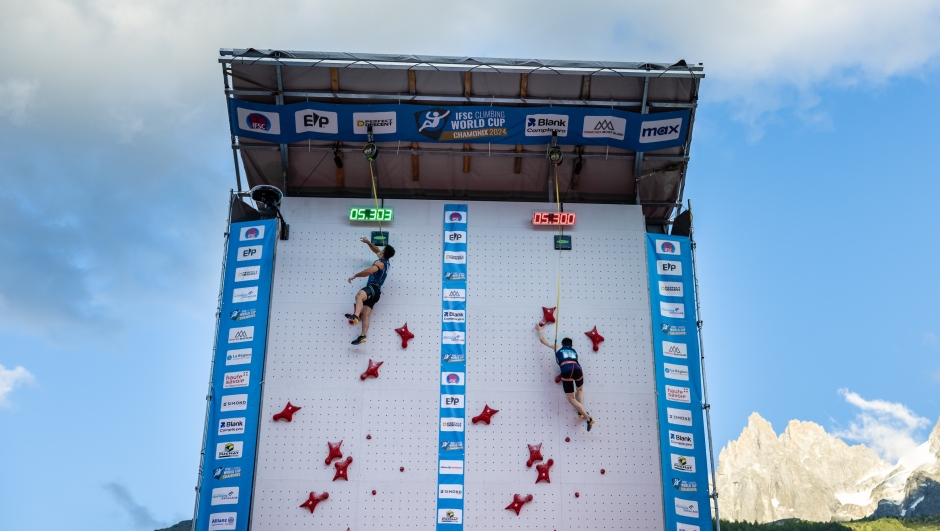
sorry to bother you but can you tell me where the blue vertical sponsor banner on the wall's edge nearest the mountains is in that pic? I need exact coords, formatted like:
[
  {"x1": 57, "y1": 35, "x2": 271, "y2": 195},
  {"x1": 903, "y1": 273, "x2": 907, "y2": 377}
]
[{"x1": 646, "y1": 234, "x2": 712, "y2": 531}]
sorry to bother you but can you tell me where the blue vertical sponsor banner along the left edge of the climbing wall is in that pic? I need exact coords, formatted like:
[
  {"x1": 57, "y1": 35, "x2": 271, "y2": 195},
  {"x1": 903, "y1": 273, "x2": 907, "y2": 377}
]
[{"x1": 196, "y1": 219, "x2": 277, "y2": 531}]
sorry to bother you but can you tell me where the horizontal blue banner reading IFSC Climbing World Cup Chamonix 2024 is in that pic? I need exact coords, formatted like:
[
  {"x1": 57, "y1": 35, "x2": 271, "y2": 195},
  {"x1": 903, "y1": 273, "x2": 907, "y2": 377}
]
[{"x1": 229, "y1": 99, "x2": 690, "y2": 151}]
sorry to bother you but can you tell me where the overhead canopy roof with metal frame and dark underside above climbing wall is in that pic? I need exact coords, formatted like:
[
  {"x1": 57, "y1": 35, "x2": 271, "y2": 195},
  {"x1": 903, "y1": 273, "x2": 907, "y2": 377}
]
[{"x1": 219, "y1": 48, "x2": 704, "y2": 224}]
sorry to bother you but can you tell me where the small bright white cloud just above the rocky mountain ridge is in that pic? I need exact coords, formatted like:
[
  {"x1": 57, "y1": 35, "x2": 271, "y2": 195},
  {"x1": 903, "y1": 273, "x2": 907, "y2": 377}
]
[{"x1": 834, "y1": 389, "x2": 930, "y2": 462}]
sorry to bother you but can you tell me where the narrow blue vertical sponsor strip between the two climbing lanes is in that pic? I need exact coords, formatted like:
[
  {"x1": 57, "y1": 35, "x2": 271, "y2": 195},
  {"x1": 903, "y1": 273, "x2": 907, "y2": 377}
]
[{"x1": 436, "y1": 205, "x2": 468, "y2": 531}]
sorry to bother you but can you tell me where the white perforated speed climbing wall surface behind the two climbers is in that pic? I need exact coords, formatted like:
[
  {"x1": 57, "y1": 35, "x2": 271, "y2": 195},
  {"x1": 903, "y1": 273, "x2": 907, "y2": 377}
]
[{"x1": 251, "y1": 198, "x2": 663, "y2": 531}]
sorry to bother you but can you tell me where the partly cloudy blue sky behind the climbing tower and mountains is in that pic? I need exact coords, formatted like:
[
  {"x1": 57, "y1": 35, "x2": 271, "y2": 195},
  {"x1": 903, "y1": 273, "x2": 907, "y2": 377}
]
[{"x1": 0, "y1": 0, "x2": 940, "y2": 530}]
